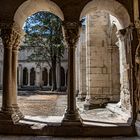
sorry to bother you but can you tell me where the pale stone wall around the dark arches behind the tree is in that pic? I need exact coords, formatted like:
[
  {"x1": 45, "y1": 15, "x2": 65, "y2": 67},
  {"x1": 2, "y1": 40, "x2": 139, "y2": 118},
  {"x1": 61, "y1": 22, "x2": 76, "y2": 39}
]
[{"x1": 18, "y1": 48, "x2": 68, "y2": 88}]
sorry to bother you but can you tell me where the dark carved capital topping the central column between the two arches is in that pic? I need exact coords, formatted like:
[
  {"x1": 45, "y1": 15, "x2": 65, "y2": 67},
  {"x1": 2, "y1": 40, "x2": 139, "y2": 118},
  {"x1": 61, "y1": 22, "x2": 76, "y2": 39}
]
[{"x1": 63, "y1": 22, "x2": 81, "y2": 47}]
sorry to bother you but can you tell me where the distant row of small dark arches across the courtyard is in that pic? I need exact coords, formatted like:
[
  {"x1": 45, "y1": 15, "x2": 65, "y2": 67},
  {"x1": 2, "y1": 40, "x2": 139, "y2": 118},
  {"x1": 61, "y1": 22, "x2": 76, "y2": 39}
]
[{"x1": 17, "y1": 65, "x2": 67, "y2": 90}]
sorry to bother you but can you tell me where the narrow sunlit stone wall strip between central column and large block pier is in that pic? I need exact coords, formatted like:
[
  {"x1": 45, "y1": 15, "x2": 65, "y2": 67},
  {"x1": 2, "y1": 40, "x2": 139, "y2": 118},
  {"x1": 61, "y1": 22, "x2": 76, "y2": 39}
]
[{"x1": 76, "y1": 25, "x2": 86, "y2": 101}]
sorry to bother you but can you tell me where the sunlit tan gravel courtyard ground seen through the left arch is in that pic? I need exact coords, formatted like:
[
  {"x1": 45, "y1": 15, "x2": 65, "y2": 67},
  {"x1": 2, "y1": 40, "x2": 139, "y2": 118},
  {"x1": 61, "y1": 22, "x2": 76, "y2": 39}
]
[{"x1": 18, "y1": 95, "x2": 66, "y2": 116}]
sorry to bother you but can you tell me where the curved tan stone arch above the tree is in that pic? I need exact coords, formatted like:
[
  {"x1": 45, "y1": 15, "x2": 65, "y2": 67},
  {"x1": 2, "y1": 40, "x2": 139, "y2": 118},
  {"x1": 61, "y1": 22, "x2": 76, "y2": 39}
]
[{"x1": 14, "y1": 0, "x2": 64, "y2": 28}]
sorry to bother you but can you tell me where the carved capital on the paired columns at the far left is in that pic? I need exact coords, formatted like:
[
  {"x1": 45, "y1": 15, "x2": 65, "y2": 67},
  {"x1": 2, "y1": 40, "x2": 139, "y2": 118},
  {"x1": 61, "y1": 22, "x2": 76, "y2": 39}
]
[{"x1": 0, "y1": 23, "x2": 23, "y2": 49}]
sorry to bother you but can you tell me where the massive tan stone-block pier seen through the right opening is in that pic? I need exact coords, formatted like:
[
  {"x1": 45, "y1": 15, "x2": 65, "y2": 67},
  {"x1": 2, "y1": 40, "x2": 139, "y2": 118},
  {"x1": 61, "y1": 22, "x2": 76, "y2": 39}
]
[{"x1": 81, "y1": 12, "x2": 120, "y2": 108}]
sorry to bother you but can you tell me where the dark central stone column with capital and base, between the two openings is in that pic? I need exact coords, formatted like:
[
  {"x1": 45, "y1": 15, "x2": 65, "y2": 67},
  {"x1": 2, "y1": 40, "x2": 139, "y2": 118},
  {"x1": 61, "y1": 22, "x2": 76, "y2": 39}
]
[{"x1": 63, "y1": 22, "x2": 81, "y2": 125}]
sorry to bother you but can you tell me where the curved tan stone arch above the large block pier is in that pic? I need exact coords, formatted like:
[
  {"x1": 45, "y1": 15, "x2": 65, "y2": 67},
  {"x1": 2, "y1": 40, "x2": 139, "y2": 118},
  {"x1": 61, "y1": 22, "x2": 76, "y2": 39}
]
[{"x1": 80, "y1": 0, "x2": 131, "y2": 29}]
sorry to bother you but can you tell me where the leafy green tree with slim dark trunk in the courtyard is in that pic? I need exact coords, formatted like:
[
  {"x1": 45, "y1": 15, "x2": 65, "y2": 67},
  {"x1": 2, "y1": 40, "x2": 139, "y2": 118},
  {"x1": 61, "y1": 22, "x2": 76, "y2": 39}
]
[{"x1": 21, "y1": 12, "x2": 65, "y2": 90}]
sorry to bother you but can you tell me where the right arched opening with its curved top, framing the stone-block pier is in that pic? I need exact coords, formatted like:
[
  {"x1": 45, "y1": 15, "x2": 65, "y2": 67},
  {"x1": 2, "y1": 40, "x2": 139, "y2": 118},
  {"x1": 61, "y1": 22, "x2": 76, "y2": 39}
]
[{"x1": 76, "y1": 0, "x2": 132, "y2": 123}]
